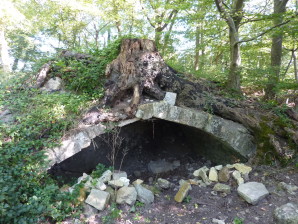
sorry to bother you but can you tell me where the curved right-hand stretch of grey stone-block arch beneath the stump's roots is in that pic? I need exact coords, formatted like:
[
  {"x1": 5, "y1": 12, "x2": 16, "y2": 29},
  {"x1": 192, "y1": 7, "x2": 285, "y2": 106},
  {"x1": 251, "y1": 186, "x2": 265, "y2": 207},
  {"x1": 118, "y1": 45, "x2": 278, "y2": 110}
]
[{"x1": 136, "y1": 102, "x2": 256, "y2": 159}]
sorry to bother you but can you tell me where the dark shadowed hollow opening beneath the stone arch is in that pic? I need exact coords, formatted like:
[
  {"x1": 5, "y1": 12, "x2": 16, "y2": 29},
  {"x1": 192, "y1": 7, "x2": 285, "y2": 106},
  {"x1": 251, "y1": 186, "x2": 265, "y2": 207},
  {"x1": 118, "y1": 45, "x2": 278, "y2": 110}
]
[{"x1": 49, "y1": 119, "x2": 244, "y2": 182}]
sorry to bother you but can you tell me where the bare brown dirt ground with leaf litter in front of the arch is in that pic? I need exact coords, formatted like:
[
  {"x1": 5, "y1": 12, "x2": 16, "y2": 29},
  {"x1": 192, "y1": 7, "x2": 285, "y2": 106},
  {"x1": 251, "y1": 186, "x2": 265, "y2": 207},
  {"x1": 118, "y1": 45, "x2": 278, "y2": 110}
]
[{"x1": 77, "y1": 161, "x2": 298, "y2": 224}]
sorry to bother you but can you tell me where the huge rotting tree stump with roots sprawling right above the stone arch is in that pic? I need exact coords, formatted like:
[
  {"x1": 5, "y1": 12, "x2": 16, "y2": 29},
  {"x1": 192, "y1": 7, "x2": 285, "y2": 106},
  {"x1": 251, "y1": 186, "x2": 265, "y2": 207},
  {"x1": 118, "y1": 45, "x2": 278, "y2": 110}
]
[{"x1": 98, "y1": 39, "x2": 298, "y2": 163}]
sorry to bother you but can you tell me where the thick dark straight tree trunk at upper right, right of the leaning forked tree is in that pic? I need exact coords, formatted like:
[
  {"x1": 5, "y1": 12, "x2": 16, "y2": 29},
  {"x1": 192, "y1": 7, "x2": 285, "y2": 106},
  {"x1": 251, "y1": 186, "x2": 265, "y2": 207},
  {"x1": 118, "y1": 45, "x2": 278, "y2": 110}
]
[{"x1": 265, "y1": 0, "x2": 288, "y2": 99}]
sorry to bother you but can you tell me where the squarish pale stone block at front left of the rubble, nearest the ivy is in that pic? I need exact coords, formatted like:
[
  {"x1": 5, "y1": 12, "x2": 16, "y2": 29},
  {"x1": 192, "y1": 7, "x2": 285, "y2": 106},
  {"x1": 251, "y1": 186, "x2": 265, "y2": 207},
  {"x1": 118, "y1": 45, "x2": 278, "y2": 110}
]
[{"x1": 85, "y1": 189, "x2": 110, "y2": 211}]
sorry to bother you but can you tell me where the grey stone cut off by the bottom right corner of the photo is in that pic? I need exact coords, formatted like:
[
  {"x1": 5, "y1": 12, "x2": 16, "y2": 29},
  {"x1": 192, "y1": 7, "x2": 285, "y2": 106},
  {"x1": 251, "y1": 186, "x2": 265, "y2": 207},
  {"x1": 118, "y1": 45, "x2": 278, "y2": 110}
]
[{"x1": 274, "y1": 203, "x2": 298, "y2": 224}]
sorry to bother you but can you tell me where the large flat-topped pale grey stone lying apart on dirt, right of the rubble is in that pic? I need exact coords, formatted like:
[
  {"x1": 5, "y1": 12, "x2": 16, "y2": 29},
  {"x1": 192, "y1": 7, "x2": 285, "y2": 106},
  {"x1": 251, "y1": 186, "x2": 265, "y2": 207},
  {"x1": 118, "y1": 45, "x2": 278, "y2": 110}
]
[{"x1": 237, "y1": 182, "x2": 269, "y2": 205}]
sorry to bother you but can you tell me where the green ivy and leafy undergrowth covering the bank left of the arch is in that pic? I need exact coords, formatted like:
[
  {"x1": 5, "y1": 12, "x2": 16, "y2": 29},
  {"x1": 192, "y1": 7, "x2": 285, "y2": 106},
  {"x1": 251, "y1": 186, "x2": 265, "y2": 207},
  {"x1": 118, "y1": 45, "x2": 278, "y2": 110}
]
[{"x1": 0, "y1": 40, "x2": 120, "y2": 224}]
